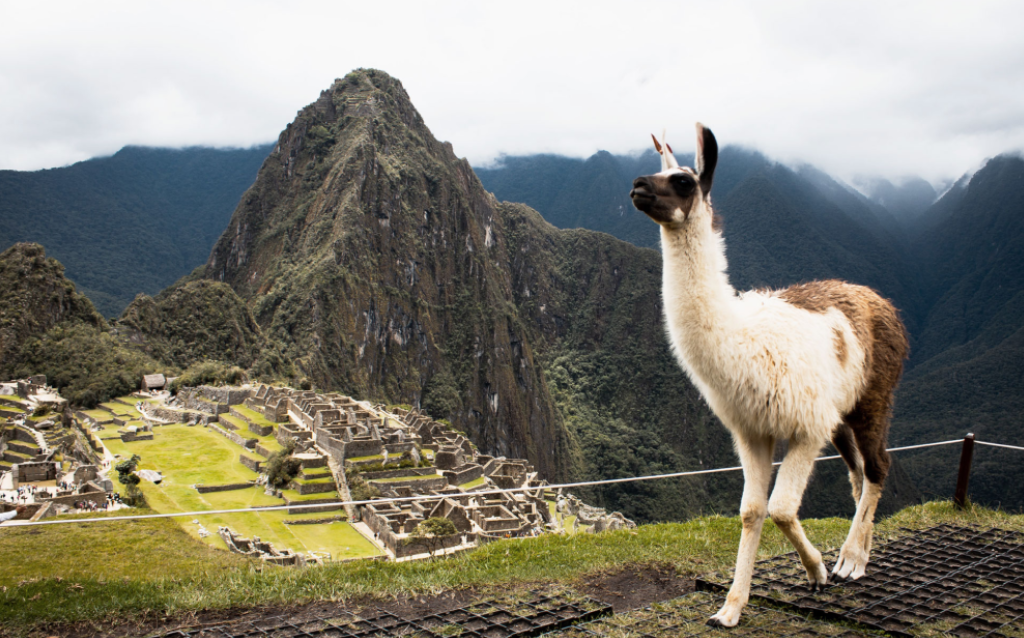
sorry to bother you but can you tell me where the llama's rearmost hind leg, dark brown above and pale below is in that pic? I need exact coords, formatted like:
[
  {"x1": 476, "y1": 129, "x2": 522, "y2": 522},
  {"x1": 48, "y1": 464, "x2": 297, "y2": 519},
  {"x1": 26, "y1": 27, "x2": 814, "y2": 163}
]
[{"x1": 833, "y1": 426, "x2": 889, "y2": 581}]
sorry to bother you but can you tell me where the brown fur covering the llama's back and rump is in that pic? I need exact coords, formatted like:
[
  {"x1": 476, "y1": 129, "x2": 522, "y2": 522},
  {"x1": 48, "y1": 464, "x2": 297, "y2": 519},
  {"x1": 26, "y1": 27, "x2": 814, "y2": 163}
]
[{"x1": 778, "y1": 280, "x2": 909, "y2": 485}]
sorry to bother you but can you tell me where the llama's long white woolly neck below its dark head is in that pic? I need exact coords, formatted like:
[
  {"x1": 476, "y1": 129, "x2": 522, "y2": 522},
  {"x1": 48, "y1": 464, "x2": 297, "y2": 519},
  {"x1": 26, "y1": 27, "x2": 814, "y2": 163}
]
[{"x1": 662, "y1": 211, "x2": 739, "y2": 364}]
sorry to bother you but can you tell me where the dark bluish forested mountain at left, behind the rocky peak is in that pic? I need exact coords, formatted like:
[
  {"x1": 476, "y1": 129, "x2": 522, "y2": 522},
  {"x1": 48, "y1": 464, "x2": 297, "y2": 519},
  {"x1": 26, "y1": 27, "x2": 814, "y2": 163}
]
[{"x1": 0, "y1": 145, "x2": 270, "y2": 316}]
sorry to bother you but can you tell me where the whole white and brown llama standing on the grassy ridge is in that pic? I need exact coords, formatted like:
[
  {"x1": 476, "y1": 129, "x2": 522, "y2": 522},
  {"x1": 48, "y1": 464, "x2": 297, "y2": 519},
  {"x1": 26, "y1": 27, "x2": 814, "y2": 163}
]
[{"x1": 630, "y1": 123, "x2": 907, "y2": 627}]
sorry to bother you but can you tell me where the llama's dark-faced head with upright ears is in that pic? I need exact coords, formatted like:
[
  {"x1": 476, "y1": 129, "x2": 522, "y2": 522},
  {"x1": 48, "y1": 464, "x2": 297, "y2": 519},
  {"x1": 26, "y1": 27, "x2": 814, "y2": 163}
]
[{"x1": 630, "y1": 122, "x2": 718, "y2": 227}]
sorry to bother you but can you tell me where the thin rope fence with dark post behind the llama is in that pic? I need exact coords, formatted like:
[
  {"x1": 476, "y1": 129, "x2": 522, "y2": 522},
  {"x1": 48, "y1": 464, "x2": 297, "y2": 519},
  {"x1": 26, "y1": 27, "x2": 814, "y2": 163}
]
[{"x1": 2, "y1": 434, "x2": 1024, "y2": 527}]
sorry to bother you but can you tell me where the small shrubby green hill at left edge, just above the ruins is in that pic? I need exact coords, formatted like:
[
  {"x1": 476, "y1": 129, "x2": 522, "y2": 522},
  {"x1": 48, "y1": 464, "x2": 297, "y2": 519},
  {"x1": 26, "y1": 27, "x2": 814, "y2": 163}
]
[{"x1": 0, "y1": 244, "x2": 161, "y2": 407}]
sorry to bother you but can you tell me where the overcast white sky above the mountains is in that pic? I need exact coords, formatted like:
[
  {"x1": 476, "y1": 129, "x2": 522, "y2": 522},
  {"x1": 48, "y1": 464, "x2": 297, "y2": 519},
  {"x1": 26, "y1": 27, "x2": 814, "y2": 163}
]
[{"x1": 0, "y1": 0, "x2": 1024, "y2": 182}]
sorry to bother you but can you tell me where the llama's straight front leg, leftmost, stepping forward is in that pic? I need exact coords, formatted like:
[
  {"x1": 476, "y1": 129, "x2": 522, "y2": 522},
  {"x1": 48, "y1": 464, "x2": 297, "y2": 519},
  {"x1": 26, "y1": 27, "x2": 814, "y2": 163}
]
[{"x1": 708, "y1": 436, "x2": 775, "y2": 627}]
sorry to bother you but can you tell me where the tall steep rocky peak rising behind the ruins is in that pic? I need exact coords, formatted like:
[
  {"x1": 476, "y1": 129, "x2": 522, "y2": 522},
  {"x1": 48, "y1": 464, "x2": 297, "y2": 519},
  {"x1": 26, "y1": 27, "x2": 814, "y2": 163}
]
[{"x1": 206, "y1": 71, "x2": 569, "y2": 477}]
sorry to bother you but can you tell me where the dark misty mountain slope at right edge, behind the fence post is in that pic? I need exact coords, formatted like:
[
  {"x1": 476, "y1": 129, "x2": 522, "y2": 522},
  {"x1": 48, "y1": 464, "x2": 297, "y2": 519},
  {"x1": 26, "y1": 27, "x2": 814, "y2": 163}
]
[{"x1": 895, "y1": 156, "x2": 1024, "y2": 508}]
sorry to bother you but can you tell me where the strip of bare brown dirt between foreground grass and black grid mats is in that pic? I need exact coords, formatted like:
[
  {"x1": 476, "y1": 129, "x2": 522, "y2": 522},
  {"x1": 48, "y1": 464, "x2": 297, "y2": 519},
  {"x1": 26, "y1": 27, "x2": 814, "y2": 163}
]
[{"x1": 28, "y1": 563, "x2": 693, "y2": 638}]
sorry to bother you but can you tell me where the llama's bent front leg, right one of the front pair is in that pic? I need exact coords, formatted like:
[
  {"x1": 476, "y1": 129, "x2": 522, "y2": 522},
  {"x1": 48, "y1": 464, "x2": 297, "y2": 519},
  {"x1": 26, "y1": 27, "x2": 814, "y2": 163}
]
[{"x1": 768, "y1": 438, "x2": 828, "y2": 590}]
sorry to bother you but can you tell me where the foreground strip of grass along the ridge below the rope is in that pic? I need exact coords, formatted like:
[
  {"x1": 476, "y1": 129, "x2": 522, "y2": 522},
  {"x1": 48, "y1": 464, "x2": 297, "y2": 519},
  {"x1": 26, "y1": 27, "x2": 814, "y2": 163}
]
[{"x1": 0, "y1": 503, "x2": 1024, "y2": 635}]
